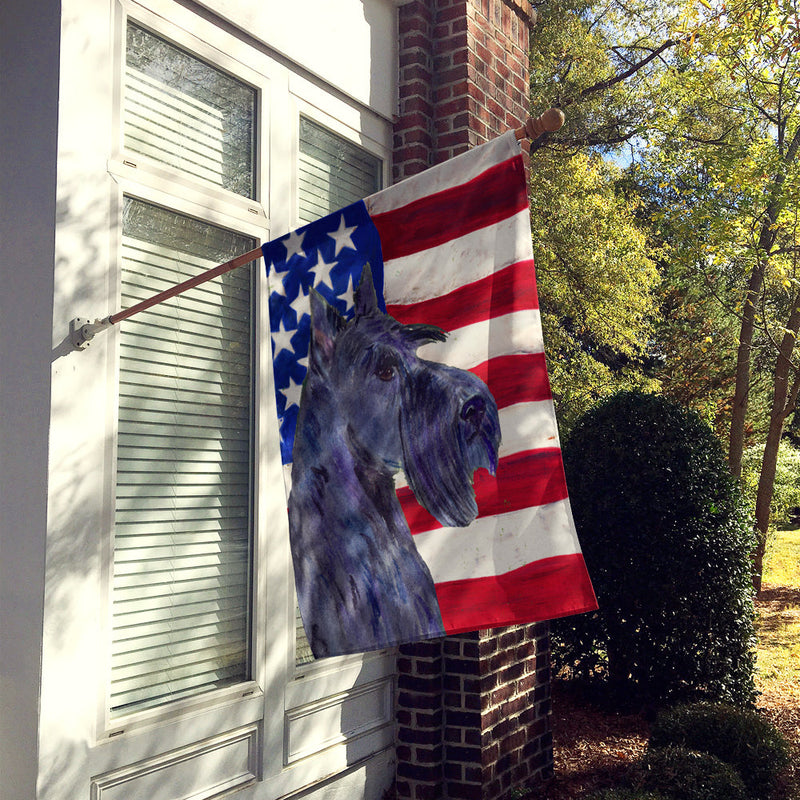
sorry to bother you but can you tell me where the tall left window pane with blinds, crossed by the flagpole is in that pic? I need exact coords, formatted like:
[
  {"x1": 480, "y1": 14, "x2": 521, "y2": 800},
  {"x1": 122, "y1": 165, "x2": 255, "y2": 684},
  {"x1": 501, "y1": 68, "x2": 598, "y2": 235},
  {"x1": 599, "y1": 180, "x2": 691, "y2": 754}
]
[{"x1": 111, "y1": 198, "x2": 254, "y2": 715}]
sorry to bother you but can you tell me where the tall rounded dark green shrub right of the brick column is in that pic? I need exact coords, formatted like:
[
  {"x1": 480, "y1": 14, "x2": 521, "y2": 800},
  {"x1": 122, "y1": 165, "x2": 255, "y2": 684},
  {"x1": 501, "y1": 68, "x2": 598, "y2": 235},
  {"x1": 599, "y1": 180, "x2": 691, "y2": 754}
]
[{"x1": 553, "y1": 392, "x2": 755, "y2": 705}]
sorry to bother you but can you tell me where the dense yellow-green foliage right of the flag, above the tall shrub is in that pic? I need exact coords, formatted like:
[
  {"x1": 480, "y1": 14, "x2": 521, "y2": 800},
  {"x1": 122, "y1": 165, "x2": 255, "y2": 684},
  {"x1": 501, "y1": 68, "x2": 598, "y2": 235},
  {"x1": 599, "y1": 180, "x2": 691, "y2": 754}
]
[{"x1": 531, "y1": 148, "x2": 659, "y2": 430}]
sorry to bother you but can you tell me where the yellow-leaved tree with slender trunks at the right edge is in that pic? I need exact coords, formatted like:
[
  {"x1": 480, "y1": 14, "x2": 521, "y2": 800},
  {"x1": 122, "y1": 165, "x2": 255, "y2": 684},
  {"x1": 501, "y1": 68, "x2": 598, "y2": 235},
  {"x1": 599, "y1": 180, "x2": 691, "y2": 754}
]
[{"x1": 637, "y1": 0, "x2": 800, "y2": 586}]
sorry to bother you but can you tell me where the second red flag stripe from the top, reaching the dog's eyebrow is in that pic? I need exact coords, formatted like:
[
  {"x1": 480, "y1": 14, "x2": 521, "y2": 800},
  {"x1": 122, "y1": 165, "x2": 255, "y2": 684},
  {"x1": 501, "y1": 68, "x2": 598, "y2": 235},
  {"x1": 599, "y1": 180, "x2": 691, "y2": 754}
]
[{"x1": 386, "y1": 259, "x2": 539, "y2": 331}]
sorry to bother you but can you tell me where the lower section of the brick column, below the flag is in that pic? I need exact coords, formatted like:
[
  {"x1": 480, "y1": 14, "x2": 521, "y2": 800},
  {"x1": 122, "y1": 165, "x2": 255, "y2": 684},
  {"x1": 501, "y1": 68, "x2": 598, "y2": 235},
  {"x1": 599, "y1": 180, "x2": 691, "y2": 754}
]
[{"x1": 395, "y1": 623, "x2": 553, "y2": 800}]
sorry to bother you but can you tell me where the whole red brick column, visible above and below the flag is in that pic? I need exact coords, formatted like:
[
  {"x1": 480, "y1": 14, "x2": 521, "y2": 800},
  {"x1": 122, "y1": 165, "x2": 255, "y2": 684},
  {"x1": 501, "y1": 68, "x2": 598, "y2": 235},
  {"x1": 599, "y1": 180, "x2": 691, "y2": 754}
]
[{"x1": 393, "y1": 0, "x2": 553, "y2": 800}]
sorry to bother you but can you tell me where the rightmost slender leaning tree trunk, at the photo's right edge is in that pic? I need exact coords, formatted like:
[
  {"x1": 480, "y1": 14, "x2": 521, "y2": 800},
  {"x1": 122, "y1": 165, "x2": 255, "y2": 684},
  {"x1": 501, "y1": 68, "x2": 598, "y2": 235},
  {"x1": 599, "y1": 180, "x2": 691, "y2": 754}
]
[{"x1": 753, "y1": 297, "x2": 800, "y2": 592}]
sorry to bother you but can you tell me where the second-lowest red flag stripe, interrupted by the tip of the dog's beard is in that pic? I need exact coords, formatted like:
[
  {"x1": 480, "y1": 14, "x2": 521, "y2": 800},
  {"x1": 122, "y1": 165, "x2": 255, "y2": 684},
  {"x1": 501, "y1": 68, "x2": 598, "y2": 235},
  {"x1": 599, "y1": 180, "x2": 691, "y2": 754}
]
[{"x1": 397, "y1": 447, "x2": 567, "y2": 533}]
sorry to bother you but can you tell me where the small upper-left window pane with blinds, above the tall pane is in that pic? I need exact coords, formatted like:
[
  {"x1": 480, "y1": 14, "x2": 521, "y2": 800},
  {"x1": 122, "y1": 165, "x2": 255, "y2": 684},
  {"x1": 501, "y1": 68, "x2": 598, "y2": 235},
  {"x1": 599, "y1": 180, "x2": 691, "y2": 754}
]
[{"x1": 124, "y1": 23, "x2": 256, "y2": 197}]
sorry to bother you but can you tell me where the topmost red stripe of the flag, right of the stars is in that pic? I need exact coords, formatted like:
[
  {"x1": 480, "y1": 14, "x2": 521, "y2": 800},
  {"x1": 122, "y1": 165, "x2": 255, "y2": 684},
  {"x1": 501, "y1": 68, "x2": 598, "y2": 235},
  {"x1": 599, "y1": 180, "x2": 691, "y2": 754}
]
[{"x1": 372, "y1": 156, "x2": 528, "y2": 261}]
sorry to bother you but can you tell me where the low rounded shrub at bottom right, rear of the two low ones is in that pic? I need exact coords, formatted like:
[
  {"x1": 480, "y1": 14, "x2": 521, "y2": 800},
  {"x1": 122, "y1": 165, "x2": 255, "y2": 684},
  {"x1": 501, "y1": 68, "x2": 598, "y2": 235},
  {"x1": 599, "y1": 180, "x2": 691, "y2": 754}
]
[{"x1": 650, "y1": 703, "x2": 789, "y2": 797}]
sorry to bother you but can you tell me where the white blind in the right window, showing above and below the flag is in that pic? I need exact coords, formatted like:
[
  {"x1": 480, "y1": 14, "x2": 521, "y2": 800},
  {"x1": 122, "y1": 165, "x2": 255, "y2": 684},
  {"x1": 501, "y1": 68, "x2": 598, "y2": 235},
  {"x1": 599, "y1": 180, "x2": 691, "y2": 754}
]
[{"x1": 295, "y1": 117, "x2": 382, "y2": 664}]
